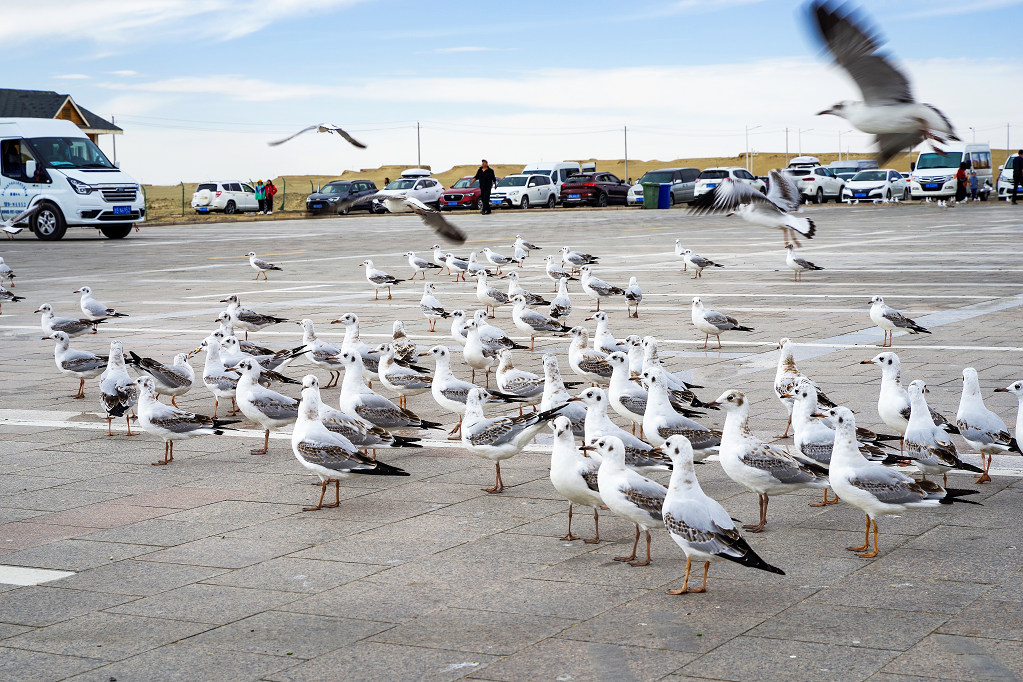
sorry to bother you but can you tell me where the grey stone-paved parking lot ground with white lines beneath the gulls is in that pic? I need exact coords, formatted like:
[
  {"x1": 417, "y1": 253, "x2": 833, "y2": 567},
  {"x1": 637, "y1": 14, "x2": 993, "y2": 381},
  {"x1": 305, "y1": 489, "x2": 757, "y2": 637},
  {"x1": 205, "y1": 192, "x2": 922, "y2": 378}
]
[{"x1": 0, "y1": 203, "x2": 1023, "y2": 681}]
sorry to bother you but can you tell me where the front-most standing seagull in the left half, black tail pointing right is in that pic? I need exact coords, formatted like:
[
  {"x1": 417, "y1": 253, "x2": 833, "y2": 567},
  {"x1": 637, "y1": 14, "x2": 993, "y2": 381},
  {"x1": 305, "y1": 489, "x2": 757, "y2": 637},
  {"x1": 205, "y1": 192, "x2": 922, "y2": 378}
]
[{"x1": 292, "y1": 377, "x2": 408, "y2": 511}]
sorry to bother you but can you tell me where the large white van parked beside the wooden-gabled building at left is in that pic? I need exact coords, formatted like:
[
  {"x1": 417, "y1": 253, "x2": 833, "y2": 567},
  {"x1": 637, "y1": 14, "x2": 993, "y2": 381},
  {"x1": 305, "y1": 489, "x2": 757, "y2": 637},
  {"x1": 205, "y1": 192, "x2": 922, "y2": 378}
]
[{"x1": 0, "y1": 119, "x2": 145, "y2": 241}]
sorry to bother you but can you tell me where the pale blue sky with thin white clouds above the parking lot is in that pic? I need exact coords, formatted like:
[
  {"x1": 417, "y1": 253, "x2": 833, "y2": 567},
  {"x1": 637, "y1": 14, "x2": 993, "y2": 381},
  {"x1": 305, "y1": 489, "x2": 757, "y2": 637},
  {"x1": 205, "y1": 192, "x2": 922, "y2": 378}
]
[{"x1": 0, "y1": 0, "x2": 1023, "y2": 184}]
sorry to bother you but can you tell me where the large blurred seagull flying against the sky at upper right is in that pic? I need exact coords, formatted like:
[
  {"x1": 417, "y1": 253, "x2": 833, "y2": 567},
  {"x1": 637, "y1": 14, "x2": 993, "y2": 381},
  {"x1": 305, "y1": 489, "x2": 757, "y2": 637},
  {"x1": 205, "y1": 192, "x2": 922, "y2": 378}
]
[{"x1": 809, "y1": 0, "x2": 960, "y2": 168}]
